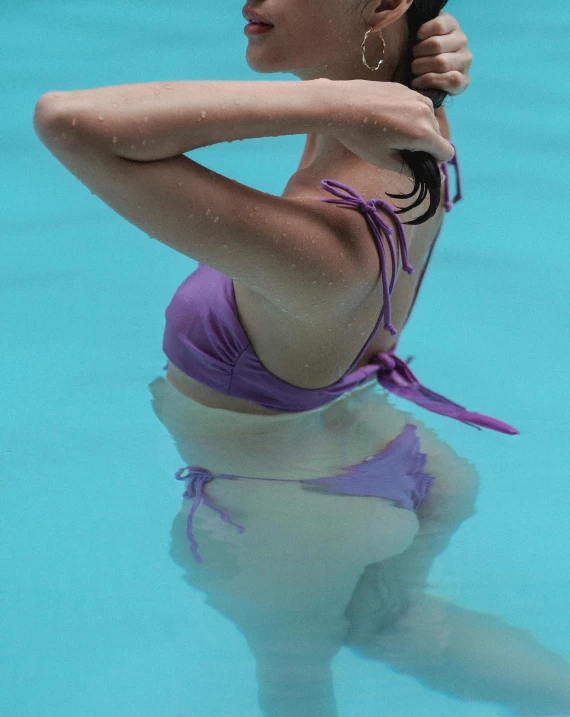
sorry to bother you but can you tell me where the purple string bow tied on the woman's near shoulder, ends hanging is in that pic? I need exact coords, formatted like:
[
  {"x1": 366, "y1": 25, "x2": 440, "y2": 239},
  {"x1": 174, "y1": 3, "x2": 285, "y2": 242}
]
[{"x1": 318, "y1": 179, "x2": 414, "y2": 336}]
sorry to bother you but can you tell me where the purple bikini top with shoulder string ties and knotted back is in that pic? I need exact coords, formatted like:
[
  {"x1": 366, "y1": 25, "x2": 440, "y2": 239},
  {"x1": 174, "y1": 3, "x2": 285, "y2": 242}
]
[{"x1": 163, "y1": 145, "x2": 518, "y2": 435}]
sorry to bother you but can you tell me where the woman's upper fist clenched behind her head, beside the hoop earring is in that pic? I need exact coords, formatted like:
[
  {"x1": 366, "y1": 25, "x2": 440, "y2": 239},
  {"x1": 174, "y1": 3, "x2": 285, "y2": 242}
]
[{"x1": 412, "y1": 12, "x2": 473, "y2": 95}]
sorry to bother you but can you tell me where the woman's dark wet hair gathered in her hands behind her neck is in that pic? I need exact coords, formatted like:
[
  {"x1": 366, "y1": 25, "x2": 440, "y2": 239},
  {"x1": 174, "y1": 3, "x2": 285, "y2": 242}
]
[{"x1": 388, "y1": 0, "x2": 447, "y2": 224}]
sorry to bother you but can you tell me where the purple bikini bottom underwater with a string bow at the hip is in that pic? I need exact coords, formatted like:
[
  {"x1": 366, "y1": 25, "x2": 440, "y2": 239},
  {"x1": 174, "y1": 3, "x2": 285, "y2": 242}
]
[{"x1": 175, "y1": 423, "x2": 435, "y2": 563}]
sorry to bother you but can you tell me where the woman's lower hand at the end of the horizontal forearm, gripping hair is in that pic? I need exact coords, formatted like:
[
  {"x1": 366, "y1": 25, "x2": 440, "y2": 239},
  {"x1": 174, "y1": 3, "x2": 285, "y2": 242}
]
[{"x1": 324, "y1": 80, "x2": 455, "y2": 172}]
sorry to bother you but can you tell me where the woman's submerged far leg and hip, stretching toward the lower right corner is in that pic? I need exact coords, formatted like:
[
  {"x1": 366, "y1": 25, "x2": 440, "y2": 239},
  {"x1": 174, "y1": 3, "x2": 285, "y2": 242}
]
[{"x1": 345, "y1": 420, "x2": 570, "y2": 716}]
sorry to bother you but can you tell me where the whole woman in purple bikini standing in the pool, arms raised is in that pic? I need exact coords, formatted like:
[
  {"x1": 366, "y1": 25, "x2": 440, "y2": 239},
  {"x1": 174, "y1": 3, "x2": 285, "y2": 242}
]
[{"x1": 35, "y1": 0, "x2": 569, "y2": 717}]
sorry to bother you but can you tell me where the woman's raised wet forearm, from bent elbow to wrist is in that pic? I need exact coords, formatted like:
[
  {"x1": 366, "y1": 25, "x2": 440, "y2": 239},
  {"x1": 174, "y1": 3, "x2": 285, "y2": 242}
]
[{"x1": 36, "y1": 79, "x2": 334, "y2": 161}]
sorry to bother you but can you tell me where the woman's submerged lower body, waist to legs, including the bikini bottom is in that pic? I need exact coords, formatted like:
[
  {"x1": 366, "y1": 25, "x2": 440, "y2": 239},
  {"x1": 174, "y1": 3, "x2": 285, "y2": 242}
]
[{"x1": 149, "y1": 377, "x2": 570, "y2": 717}]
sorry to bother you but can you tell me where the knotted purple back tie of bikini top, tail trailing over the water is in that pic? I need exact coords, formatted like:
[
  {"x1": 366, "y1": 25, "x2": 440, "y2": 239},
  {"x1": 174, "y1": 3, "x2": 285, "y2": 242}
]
[{"x1": 370, "y1": 351, "x2": 519, "y2": 436}]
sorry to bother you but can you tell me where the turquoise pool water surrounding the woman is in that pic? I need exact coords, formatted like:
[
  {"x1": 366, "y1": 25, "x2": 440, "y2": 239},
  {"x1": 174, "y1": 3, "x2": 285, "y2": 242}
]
[{"x1": 0, "y1": 0, "x2": 570, "y2": 717}]
